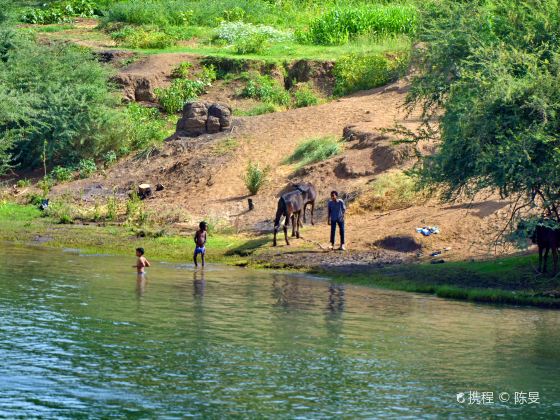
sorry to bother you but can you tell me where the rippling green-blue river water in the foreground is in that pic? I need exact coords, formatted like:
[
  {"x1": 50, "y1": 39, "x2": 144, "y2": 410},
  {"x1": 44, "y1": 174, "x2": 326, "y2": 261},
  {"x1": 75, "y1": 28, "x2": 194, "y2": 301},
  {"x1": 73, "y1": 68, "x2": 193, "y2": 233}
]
[{"x1": 0, "y1": 244, "x2": 560, "y2": 418}]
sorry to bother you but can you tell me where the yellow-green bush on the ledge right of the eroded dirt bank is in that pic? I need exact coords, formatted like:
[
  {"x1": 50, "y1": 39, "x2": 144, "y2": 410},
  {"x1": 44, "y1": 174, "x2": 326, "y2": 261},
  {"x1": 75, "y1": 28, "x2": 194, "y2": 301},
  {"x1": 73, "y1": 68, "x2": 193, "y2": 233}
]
[{"x1": 333, "y1": 54, "x2": 408, "y2": 96}]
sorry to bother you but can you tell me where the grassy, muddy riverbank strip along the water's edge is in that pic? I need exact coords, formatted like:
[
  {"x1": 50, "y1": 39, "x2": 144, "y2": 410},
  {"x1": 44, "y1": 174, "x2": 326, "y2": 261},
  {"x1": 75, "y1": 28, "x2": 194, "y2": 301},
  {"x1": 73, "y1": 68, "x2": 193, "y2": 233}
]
[{"x1": 0, "y1": 203, "x2": 560, "y2": 308}]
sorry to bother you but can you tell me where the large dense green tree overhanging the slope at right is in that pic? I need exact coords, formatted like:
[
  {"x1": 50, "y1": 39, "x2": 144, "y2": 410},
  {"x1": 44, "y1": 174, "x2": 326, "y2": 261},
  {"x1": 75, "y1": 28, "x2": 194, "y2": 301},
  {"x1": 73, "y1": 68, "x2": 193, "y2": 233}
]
[{"x1": 409, "y1": 0, "x2": 560, "y2": 220}]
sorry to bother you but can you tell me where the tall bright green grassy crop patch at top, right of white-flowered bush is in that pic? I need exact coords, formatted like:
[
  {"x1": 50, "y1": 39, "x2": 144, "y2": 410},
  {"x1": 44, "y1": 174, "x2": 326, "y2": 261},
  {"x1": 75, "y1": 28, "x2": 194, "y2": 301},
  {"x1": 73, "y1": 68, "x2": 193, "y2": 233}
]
[{"x1": 298, "y1": 4, "x2": 417, "y2": 45}]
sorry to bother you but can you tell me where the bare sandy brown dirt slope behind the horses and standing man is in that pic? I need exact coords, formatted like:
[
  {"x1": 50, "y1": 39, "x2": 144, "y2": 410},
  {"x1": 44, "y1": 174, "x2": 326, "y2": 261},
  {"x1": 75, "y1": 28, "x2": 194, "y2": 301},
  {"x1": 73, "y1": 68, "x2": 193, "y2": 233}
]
[{"x1": 58, "y1": 72, "x2": 507, "y2": 259}]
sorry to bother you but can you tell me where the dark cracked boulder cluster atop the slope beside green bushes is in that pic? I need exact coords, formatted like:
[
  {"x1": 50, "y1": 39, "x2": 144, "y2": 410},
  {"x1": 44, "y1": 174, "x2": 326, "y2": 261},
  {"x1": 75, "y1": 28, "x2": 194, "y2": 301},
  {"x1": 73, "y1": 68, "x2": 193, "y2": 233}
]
[{"x1": 175, "y1": 102, "x2": 232, "y2": 137}]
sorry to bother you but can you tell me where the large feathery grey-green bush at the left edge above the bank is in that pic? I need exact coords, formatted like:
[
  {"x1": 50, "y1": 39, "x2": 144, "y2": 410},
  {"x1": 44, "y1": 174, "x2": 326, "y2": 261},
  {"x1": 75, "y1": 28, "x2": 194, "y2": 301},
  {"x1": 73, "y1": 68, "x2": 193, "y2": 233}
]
[{"x1": 0, "y1": 29, "x2": 127, "y2": 172}]
